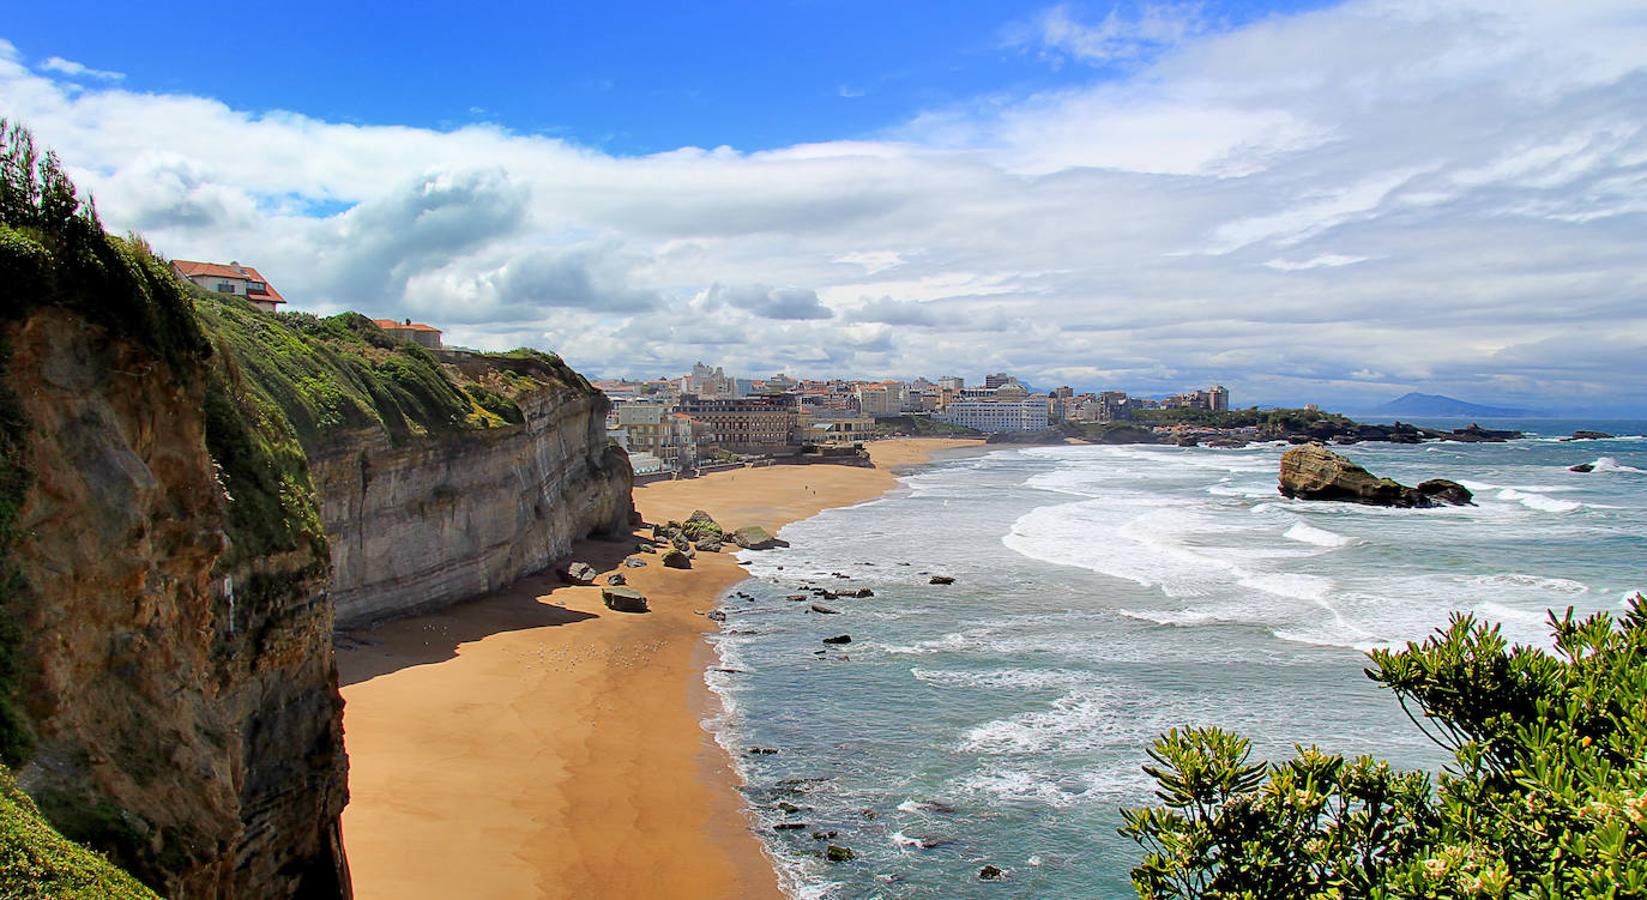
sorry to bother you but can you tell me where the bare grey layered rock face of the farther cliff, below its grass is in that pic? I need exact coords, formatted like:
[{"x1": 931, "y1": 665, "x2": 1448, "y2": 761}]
[{"x1": 310, "y1": 386, "x2": 632, "y2": 626}]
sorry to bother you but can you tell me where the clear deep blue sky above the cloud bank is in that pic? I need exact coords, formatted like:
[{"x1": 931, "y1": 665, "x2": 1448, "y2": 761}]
[{"x1": 0, "y1": 0, "x2": 1319, "y2": 155}]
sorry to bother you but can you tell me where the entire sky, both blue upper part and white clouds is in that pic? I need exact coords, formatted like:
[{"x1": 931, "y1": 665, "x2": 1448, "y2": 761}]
[{"x1": 0, "y1": 0, "x2": 1647, "y2": 415}]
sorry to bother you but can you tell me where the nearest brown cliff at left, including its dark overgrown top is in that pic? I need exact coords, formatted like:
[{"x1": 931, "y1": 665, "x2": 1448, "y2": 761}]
[{"x1": 0, "y1": 217, "x2": 349, "y2": 898}]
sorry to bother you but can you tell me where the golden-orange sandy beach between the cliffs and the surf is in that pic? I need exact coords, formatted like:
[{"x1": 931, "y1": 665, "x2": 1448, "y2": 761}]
[{"x1": 338, "y1": 438, "x2": 975, "y2": 900}]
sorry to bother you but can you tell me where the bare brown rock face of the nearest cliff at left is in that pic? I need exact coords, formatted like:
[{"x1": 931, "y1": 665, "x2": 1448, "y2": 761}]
[{"x1": 0, "y1": 307, "x2": 349, "y2": 898}]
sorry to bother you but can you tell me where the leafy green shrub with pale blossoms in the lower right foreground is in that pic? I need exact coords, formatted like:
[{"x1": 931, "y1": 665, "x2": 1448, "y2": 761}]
[{"x1": 1122, "y1": 597, "x2": 1647, "y2": 900}]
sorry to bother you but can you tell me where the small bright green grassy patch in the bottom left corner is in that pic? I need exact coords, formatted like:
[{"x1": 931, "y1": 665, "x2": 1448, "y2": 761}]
[{"x1": 0, "y1": 766, "x2": 158, "y2": 900}]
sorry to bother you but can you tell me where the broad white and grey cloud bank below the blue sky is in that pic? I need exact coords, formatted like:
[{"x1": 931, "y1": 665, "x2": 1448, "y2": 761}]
[{"x1": 0, "y1": 0, "x2": 1647, "y2": 409}]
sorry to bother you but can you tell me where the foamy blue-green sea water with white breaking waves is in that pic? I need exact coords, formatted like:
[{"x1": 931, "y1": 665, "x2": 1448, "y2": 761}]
[{"x1": 707, "y1": 422, "x2": 1647, "y2": 898}]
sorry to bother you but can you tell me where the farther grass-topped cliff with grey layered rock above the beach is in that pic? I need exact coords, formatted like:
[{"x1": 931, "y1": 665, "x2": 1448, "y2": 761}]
[{"x1": 196, "y1": 293, "x2": 632, "y2": 626}]
